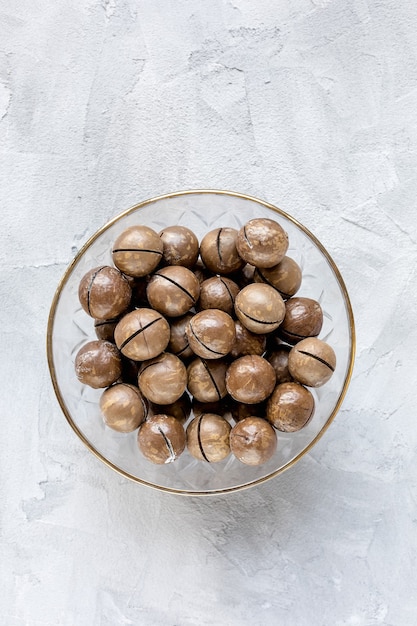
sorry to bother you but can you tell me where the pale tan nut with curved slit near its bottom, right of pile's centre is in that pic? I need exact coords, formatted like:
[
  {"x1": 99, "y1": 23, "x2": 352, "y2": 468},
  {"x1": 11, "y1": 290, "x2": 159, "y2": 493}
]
[{"x1": 235, "y1": 283, "x2": 285, "y2": 334}]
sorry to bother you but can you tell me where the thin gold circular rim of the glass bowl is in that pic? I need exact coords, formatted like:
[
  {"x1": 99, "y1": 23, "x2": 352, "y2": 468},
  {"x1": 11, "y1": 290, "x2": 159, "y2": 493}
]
[{"x1": 46, "y1": 189, "x2": 356, "y2": 497}]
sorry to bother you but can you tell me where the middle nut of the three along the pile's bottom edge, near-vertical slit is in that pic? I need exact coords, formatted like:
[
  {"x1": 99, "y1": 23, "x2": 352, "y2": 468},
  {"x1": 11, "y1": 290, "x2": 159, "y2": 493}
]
[{"x1": 186, "y1": 413, "x2": 231, "y2": 463}]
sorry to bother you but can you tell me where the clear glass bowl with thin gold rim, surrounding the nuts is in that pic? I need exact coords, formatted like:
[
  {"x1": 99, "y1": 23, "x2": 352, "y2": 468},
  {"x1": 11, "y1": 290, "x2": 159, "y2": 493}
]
[{"x1": 47, "y1": 190, "x2": 355, "y2": 496}]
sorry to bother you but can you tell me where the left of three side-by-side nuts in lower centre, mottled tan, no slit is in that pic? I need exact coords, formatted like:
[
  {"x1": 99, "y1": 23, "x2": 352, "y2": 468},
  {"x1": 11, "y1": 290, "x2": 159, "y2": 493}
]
[{"x1": 138, "y1": 352, "x2": 187, "y2": 404}]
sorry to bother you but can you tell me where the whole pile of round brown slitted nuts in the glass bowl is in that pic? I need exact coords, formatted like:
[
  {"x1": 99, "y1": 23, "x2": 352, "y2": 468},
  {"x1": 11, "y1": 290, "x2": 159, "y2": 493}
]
[{"x1": 75, "y1": 218, "x2": 336, "y2": 465}]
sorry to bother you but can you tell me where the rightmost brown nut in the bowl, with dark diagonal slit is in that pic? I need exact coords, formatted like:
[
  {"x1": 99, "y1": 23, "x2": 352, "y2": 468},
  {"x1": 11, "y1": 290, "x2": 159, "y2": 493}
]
[{"x1": 288, "y1": 337, "x2": 336, "y2": 387}]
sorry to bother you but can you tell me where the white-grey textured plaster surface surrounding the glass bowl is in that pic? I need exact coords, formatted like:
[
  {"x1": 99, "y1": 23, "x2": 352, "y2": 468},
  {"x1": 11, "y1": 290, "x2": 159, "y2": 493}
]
[{"x1": 0, "y1": 0, "x2": 417, "y2": 626}]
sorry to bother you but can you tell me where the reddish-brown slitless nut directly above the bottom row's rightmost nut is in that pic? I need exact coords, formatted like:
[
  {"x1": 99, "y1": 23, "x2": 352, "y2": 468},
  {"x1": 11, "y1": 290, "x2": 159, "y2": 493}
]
[{"x1": 226, "y1": 354, "x2": 276, "y2": 404}]
